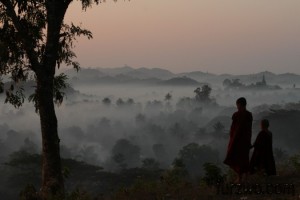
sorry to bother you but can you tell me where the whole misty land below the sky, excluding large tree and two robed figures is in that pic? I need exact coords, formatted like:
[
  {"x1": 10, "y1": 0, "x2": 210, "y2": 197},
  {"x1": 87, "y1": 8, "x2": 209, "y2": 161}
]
[{"x1": 0, "y1": 66, "x2": 300, "y2": 200}]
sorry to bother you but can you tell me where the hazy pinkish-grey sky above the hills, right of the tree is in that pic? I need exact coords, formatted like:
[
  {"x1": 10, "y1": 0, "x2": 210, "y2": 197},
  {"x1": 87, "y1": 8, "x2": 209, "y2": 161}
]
[{"x1": 66, "y1": 0, "x2": 300, "y2": 74}]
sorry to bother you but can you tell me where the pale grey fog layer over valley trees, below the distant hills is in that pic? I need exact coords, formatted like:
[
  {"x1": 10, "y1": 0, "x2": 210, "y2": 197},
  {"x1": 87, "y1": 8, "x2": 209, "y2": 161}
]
[{"x1": 0, "y1": 82, "x2": 300, "y2": 170}]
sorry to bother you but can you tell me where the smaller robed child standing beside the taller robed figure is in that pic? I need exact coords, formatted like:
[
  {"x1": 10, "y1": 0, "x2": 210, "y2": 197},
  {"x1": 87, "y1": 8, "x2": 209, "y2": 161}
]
[{"x1": 250, "y1": 119, "x2": 276, "y2": 176}]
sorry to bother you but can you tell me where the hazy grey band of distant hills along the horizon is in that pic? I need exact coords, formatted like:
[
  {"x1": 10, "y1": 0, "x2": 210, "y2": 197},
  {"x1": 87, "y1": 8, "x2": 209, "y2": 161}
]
[{"x1": 65, "y1": 66, "x2": 300, "y2": 85}]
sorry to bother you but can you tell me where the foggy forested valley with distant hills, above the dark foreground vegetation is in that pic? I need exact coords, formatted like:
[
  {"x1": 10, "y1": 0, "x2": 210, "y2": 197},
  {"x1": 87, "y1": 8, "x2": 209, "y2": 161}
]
[{"x1": 0, "y1": 66, "x2": 300, "y2": 198}]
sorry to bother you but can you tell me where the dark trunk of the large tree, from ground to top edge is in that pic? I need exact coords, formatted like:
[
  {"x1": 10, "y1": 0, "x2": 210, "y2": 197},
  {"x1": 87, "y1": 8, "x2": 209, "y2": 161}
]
[{"x1": 36, "y1": 0, "x2": 71, "y2": 200}]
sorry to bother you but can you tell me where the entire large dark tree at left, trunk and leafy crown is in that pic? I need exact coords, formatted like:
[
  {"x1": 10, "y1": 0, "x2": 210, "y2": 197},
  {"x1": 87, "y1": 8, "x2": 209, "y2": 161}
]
[{"x1": 0, "y1": 0, "x2": 125, "y2": 199}]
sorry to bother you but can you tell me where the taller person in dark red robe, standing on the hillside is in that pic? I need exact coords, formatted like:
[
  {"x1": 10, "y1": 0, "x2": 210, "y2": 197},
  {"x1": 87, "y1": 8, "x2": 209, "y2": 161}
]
[{"x1": 224, "y1": 97, "x2": 253, "y2": 183}]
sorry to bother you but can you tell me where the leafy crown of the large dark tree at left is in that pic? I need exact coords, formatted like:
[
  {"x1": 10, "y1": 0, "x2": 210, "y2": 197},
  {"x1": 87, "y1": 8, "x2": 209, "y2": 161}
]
[{"x1": 0, "y1": 0, "x2": 116, "y2": 107}]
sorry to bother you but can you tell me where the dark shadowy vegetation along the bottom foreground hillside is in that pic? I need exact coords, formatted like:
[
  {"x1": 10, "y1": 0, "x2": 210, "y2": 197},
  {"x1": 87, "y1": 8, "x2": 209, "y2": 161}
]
[{"x1": 0, "y1": 147, "x2": 300, "y2": 200}]
